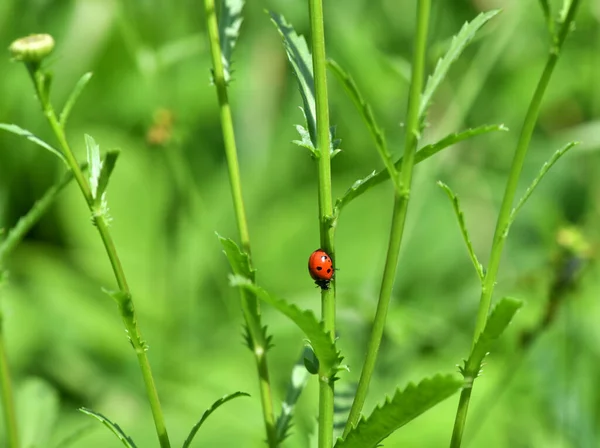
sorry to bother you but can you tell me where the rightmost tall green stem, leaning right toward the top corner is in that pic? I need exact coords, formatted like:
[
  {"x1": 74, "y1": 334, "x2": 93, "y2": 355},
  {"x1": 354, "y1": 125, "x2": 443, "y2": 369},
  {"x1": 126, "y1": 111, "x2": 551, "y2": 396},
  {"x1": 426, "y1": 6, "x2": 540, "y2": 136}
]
[{"x1": 450, "y1": 0, "x2": 579, "y2": 448}]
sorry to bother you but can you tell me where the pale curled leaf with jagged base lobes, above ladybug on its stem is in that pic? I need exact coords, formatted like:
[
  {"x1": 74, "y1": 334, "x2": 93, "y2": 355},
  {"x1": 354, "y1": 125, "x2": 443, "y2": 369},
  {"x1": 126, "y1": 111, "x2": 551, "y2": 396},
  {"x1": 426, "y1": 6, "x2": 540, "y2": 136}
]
[{"x1": 269, "y1": 11, "x2": 341, "y2": 157}]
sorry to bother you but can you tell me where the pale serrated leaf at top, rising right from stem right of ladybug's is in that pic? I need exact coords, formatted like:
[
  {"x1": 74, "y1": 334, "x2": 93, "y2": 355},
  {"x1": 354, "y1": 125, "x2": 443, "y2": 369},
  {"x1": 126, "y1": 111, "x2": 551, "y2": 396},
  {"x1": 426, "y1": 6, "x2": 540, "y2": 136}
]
[{"x1": 419, "y1": 10, "x2": 500, "y2": 122}]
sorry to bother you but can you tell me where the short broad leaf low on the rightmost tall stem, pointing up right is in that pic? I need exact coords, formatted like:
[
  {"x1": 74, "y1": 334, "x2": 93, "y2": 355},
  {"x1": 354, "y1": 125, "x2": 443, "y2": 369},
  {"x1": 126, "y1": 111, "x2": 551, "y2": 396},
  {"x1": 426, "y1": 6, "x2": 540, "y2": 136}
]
[{"x1": 459, "y1": 297, "x2": 523, "y2": 380}]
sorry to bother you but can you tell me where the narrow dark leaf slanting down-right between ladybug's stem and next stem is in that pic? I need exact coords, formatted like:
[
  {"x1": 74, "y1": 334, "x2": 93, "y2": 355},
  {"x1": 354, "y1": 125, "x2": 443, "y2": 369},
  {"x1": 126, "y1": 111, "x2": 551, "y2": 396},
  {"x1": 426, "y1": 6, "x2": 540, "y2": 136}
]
[{"x1": 327, "y1": 60, "x2": 400, "y2": 194}]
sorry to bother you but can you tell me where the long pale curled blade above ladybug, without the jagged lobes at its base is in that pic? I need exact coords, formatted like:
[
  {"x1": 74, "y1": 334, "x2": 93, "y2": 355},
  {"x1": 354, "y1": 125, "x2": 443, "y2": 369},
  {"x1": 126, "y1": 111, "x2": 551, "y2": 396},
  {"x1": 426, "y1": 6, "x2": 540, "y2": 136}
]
[{"x1": 268, "y1": 11, "x2": 317, "y2": 155}]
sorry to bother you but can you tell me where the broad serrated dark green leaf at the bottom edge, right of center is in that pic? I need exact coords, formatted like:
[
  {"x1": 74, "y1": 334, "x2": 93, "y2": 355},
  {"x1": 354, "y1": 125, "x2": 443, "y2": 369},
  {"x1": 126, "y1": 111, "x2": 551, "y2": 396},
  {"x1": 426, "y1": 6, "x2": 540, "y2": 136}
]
[{"x1": 335, "y1": 375, "x2": 463, "y2": 448}]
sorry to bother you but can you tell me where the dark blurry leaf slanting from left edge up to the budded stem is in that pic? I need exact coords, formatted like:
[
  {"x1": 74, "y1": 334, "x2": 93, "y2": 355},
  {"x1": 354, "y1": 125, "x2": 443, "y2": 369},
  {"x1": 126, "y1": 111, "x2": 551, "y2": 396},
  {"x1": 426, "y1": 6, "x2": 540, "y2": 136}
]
[{"x1": 0, "y1": 165, "x2": 85, "y2": 266}]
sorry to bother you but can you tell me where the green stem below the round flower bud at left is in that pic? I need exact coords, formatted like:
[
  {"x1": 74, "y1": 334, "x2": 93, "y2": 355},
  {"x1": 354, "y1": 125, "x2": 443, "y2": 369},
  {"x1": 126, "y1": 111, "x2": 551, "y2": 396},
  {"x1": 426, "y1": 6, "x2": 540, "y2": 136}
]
[{"x1": 28, "y1": 66, "x2": 171, "y2": 448}]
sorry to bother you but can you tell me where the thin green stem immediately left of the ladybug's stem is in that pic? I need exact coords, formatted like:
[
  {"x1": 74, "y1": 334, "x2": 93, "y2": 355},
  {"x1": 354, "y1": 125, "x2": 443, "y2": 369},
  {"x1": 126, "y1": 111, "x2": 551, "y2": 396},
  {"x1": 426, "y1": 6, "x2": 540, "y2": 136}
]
[{"x1": 204, "y1": 0, "x2": 278, "y2": 447}]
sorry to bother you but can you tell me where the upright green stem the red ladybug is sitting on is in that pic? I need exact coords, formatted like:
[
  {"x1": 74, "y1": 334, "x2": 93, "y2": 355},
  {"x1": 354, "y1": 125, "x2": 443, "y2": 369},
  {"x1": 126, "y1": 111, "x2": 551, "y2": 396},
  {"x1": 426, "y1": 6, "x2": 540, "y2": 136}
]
[{"x1": 308, "y1": 0, "x2": 335, "y2": 448}]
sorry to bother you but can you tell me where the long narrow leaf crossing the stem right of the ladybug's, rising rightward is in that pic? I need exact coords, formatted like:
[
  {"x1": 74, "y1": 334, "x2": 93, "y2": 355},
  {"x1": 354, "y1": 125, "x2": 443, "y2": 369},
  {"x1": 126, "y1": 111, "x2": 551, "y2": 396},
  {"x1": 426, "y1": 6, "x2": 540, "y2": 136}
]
[{"x1": 335, "y1": 124, "x2": 508, "y2": 213}]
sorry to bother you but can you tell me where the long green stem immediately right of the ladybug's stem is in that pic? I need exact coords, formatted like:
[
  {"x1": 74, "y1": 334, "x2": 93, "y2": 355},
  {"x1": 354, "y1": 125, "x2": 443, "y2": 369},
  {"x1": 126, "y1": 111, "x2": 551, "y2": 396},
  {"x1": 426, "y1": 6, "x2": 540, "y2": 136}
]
[{"x1": 344, "y1": 0, "x2": 431, "y2": 436}]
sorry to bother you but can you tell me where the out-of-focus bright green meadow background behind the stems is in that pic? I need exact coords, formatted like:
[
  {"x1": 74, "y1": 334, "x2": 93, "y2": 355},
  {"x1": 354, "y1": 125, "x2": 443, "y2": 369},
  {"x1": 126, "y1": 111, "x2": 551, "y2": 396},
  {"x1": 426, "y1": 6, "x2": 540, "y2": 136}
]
[{"x1": 0, "y1": 0, "x2": 600, "y2": 448}]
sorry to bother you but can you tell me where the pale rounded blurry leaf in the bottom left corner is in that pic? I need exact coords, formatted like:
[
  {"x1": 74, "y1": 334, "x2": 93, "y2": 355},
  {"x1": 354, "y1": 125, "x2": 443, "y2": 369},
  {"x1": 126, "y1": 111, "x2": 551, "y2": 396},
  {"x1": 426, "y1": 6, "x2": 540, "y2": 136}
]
[{"x1": 16, "y1": 378, "x2": 60, "y2": 448}]
